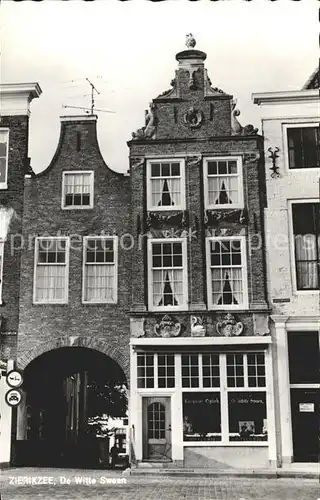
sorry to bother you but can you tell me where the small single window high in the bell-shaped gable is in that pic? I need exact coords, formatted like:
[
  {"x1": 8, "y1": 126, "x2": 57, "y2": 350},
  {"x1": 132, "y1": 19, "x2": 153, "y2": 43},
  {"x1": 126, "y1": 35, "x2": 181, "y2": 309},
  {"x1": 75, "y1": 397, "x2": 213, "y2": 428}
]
[{"x1": 62, "y1": 171, "x2": 93, "y2": 208}]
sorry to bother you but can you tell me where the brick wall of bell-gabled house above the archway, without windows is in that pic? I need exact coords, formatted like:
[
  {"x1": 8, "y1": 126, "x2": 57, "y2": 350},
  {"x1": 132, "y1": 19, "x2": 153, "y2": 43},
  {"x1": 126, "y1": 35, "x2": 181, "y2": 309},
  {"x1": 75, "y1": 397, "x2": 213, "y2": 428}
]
[{"x1": 18, "y1": 119, "x2": 131, "y2": 376}]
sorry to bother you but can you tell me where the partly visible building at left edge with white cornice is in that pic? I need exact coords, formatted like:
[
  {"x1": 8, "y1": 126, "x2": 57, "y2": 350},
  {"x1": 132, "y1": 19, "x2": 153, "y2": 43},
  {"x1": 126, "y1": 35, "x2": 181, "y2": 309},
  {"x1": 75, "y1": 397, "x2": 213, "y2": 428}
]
[{"x1": 0, "y1": 83, "x2": 41, "y2": 463}]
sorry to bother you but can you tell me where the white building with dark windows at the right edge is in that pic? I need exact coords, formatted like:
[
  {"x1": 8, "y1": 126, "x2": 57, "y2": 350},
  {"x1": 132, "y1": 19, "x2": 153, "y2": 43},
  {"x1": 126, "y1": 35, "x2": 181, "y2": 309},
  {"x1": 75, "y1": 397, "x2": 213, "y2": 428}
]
[{"x1": 253, "y1": 71, "x2": 320, "y2": 465}]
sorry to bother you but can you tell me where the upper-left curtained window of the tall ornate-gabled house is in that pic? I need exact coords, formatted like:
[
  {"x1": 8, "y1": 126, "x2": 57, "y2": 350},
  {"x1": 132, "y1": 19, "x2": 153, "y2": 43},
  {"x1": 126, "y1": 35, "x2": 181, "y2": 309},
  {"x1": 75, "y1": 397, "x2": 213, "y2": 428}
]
[{"x1": 148, "y1": 160, "x2": 185, "y2": 210}]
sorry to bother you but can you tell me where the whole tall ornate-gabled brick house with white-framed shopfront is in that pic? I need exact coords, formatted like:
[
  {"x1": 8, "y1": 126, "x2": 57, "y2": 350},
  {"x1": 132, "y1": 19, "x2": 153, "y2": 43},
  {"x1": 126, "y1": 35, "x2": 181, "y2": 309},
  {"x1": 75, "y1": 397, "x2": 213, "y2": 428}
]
[{"x1": 128, "y1": 40, "x2": 276, "y2": 468}]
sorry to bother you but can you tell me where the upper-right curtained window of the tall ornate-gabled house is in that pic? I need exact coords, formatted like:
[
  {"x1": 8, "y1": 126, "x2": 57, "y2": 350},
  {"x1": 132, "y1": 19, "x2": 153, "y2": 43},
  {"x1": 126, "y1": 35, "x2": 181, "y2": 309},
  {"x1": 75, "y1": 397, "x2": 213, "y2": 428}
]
[{"x1": 204, "y1": 158, "x2": 243, "y2": 208}]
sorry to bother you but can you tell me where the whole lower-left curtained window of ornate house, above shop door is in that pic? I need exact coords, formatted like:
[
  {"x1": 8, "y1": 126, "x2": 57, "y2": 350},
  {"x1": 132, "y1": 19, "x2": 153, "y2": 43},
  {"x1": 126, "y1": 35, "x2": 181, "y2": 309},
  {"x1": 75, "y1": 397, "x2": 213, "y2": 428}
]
[{"x1": 148, "y1": 238, "x2": 187, "y2": 309}]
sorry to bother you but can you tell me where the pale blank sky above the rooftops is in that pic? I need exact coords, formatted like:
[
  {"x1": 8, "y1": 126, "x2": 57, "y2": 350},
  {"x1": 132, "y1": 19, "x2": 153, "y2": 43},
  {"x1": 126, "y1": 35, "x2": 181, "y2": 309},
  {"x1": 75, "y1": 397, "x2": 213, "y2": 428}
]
[{"x1": 0, "y1": 0, "x2": 319, "y2": 172}]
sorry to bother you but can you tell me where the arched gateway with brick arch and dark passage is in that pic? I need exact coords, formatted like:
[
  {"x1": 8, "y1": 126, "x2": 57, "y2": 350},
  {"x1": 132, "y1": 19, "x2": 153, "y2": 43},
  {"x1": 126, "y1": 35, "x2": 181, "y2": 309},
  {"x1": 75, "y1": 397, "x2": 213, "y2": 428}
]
[{"x1": 14, "y1": 337, "x2": 129, "y2": 467}]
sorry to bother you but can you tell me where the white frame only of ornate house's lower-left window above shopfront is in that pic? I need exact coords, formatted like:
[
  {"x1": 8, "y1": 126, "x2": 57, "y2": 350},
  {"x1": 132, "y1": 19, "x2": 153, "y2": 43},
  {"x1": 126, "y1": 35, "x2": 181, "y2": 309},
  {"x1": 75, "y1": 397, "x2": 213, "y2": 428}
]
[{"x1": 148, "y1": 238, "x2": 188, "y2": 311}]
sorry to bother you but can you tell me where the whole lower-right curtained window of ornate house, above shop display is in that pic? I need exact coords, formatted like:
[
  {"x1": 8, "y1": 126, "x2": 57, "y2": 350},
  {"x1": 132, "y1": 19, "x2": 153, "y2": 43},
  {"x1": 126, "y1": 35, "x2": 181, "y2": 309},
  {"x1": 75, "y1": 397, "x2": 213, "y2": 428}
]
[{"x1": 206, "y1": 236, "x2": 248, "y2": 309}]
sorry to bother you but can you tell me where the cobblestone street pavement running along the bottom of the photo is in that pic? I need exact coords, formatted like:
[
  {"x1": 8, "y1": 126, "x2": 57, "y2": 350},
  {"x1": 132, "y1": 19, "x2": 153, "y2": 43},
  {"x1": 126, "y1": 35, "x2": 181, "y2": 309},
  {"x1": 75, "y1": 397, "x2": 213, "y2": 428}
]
[{"x1": 0, "y1": 468, "x2": 320, "y2": 500}]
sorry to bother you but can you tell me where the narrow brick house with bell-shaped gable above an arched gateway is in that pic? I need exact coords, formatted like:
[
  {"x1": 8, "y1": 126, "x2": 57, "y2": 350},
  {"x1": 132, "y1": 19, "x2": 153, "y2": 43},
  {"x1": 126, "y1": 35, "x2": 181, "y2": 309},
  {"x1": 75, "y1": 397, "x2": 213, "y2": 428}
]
[{"x1": 13, "y1": 115, "x2": 131, "y2": 466}]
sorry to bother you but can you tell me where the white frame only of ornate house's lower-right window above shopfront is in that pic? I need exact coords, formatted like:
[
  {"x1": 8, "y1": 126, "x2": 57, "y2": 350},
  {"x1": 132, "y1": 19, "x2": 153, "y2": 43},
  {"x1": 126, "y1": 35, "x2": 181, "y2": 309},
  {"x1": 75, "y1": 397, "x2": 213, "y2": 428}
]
[{"x1": 206, "y1": 235, "x2": 249, "y2": 310}]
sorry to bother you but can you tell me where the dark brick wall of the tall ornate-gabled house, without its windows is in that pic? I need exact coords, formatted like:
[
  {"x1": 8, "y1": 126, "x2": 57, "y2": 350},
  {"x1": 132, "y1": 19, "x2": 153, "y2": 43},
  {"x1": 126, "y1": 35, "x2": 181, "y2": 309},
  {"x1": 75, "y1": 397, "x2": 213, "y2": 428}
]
[{"x1": 128, "y1": 47, "x2": 267, "y2": 336}]
